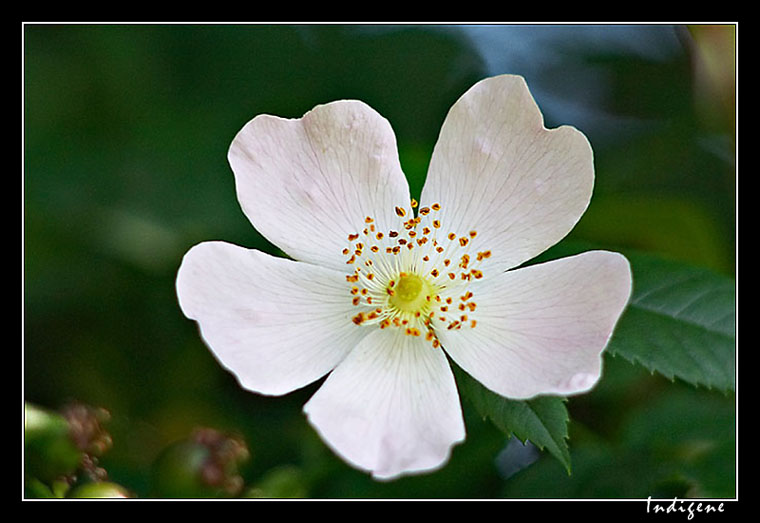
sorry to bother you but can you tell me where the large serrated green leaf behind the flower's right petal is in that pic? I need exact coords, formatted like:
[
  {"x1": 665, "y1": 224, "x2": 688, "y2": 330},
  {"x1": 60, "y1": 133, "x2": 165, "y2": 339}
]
[{"x1": 607, "y1": 254, "x2": 736, "y2": 391}]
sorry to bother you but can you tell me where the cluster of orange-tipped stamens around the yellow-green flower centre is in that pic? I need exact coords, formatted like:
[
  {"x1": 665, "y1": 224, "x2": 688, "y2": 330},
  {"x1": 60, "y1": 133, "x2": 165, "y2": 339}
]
[{"x1": 342, "y1": 200, "x2": 491, "y2": 348}]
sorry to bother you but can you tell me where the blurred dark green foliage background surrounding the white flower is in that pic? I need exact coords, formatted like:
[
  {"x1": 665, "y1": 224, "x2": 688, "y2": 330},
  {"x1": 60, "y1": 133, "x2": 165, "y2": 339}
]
[{"x1": 23, "y1": 24, "x2": 736, "y2": 498}]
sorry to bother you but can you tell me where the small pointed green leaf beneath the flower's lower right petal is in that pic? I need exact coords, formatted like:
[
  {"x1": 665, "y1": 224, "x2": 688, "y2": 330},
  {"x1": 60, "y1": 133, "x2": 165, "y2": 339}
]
[{"x1": 455, "y1": 368, "x2": 570, "y2": 474}]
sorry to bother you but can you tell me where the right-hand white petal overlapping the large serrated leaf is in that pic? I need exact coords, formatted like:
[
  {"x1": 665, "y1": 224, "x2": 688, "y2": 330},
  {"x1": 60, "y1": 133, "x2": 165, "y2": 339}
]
[{"x1": 438, "y1": 251, "x2": 631, "y2": 399}]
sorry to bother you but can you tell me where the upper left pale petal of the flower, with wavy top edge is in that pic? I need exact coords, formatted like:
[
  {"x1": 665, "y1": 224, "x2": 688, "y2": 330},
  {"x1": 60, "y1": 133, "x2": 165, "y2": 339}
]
[{"x1": 228, "y1": 100, "x2": 411, "y2": 270}]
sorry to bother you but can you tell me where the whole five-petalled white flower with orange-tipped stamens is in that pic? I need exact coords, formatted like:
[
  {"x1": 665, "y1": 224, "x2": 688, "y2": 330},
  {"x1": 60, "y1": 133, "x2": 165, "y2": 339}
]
[{"x1": 177, "y1": 75, "x2": 631, "y2": 484}]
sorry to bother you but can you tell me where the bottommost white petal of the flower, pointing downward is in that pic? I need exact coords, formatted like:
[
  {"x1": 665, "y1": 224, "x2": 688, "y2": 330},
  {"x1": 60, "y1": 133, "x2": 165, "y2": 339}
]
[{"x1": 304, "y1": 329, "x2": 465, "y2": 479}]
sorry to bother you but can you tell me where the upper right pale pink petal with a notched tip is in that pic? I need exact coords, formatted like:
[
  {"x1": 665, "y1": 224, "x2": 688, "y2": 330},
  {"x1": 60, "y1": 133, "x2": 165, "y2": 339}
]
[{"x1": 421, "y1": 75, "x2": 594, "y2": 270}]
